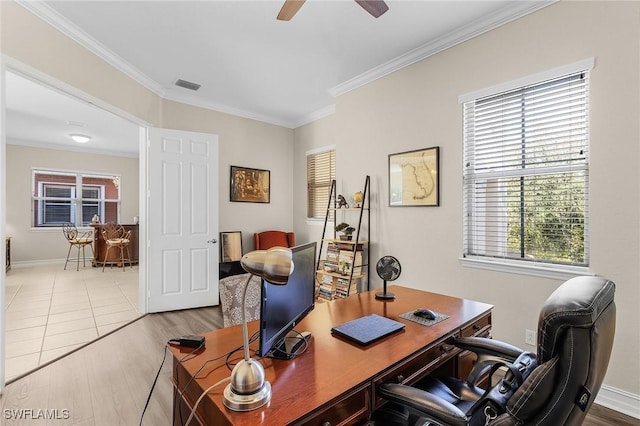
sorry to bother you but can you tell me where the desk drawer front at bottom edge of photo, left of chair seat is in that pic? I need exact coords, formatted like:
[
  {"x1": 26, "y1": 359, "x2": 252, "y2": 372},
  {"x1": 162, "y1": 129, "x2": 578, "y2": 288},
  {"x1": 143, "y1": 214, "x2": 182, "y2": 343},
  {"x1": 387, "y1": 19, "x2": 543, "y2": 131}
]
[{"x1": 293, "y1": 385, "x2": 371, "y2": 426}]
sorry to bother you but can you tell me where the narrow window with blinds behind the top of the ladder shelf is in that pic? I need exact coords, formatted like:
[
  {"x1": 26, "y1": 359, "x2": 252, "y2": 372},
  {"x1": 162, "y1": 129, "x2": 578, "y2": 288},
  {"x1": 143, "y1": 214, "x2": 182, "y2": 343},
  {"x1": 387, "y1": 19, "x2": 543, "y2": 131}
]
[{"x1": 307, "y1": 149, "x2": 336, "y2": 219}]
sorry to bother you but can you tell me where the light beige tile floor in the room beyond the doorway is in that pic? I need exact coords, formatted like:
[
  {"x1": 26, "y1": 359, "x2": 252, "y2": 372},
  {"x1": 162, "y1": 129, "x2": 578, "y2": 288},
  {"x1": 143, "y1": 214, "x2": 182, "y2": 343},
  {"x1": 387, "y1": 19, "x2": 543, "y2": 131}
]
[{"x1": 5, "y1": 262, "x2": 140, "y2": 380}]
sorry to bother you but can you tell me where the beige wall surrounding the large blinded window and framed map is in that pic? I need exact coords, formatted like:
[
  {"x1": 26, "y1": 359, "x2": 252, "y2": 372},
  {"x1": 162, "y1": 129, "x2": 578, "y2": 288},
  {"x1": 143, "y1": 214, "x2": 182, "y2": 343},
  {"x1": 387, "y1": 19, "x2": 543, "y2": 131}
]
[{"x1": 294, "y1": 2, "x2": 640, "y2": 415}]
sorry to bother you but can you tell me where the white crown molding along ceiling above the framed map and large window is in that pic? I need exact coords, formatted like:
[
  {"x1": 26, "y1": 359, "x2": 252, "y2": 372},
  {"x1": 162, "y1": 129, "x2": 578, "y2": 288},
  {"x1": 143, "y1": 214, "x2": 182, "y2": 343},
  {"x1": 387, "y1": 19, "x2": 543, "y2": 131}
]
[{"x1": 329, "y1": 0, "x2": 559, "y2": 97}]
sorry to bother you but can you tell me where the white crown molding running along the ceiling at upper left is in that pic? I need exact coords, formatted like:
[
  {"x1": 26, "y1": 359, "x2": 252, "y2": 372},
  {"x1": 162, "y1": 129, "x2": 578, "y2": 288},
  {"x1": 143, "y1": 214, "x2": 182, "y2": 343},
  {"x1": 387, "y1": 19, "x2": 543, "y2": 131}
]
[{"x1": 16, "y1": 0, "x2": 164, "y2": 97}]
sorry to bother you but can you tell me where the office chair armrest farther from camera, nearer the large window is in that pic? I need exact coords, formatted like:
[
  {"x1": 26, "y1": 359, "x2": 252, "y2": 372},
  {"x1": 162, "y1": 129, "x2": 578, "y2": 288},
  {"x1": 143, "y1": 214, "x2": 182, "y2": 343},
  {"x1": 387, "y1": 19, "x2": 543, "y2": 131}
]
[{"x1": 451, "y1": 337, "x2": 524, "y2": 386}]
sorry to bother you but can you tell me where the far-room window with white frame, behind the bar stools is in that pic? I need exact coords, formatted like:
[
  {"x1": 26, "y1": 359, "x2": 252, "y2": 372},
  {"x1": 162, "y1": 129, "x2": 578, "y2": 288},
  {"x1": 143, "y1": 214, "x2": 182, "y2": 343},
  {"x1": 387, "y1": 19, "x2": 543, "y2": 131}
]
[{"x1": 32, "y1": 170, "x2": 120, "y2": 227}]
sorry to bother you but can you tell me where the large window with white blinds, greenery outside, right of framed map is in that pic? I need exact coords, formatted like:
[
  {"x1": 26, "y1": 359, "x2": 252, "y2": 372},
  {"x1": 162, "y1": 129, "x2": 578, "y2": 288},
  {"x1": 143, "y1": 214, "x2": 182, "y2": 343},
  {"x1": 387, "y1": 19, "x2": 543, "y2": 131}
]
[{"x1": 463, "y1": 71, "x2": 589, "y2": 266}]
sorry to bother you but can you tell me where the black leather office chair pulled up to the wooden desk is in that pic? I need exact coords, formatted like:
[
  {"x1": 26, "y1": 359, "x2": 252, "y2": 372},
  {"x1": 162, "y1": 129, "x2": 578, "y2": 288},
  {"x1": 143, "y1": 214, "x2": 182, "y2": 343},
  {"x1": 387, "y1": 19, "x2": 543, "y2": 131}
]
[{"x1": 372, "y1": 277, "x2": 616, "y2": 426}]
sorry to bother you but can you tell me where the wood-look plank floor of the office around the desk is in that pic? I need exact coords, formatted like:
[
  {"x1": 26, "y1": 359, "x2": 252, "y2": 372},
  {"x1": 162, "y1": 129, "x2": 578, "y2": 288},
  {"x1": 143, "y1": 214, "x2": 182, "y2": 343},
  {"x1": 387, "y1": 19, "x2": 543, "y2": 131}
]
[{"x1": 0, "y1": 307, "x2": 639, "y2": 426}]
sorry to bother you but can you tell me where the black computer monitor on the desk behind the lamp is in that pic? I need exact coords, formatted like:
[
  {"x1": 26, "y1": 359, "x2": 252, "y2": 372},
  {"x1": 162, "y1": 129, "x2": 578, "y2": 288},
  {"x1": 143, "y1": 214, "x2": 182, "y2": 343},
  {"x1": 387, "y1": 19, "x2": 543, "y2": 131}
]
[{"x1": 258, "y1": 242, "x2": 317, "y2": 359}]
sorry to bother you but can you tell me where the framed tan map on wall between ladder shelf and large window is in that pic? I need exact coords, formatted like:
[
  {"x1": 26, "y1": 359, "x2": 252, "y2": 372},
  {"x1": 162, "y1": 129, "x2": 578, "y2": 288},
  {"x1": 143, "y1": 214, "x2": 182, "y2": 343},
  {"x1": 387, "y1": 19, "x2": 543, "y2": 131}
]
[{"x1": 389, "y1": 146, "x2": 440, "y2": 207}]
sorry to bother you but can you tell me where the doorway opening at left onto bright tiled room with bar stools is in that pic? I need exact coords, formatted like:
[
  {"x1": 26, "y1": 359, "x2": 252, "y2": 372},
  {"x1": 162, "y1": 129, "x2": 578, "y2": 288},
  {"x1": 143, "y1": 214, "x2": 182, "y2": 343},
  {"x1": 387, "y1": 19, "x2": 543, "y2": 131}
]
[{"x1": 3, "y1": 70, "x2": 144, "y2": 381}]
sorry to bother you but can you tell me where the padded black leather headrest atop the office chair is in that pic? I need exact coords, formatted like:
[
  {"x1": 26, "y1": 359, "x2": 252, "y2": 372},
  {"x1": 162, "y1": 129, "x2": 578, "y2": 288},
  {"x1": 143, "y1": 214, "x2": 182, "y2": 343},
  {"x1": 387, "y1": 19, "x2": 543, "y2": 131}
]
[{"x1": 538, "y1": 276, "x2": 615, "y2": 363}]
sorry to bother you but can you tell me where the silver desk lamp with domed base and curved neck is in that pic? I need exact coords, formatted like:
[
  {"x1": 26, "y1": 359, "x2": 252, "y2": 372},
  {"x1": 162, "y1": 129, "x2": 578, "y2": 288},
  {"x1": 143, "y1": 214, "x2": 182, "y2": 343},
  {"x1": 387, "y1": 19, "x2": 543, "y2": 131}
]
[{"x1": 223, "y1": 247, "x2": 293, "y2": 411}]
